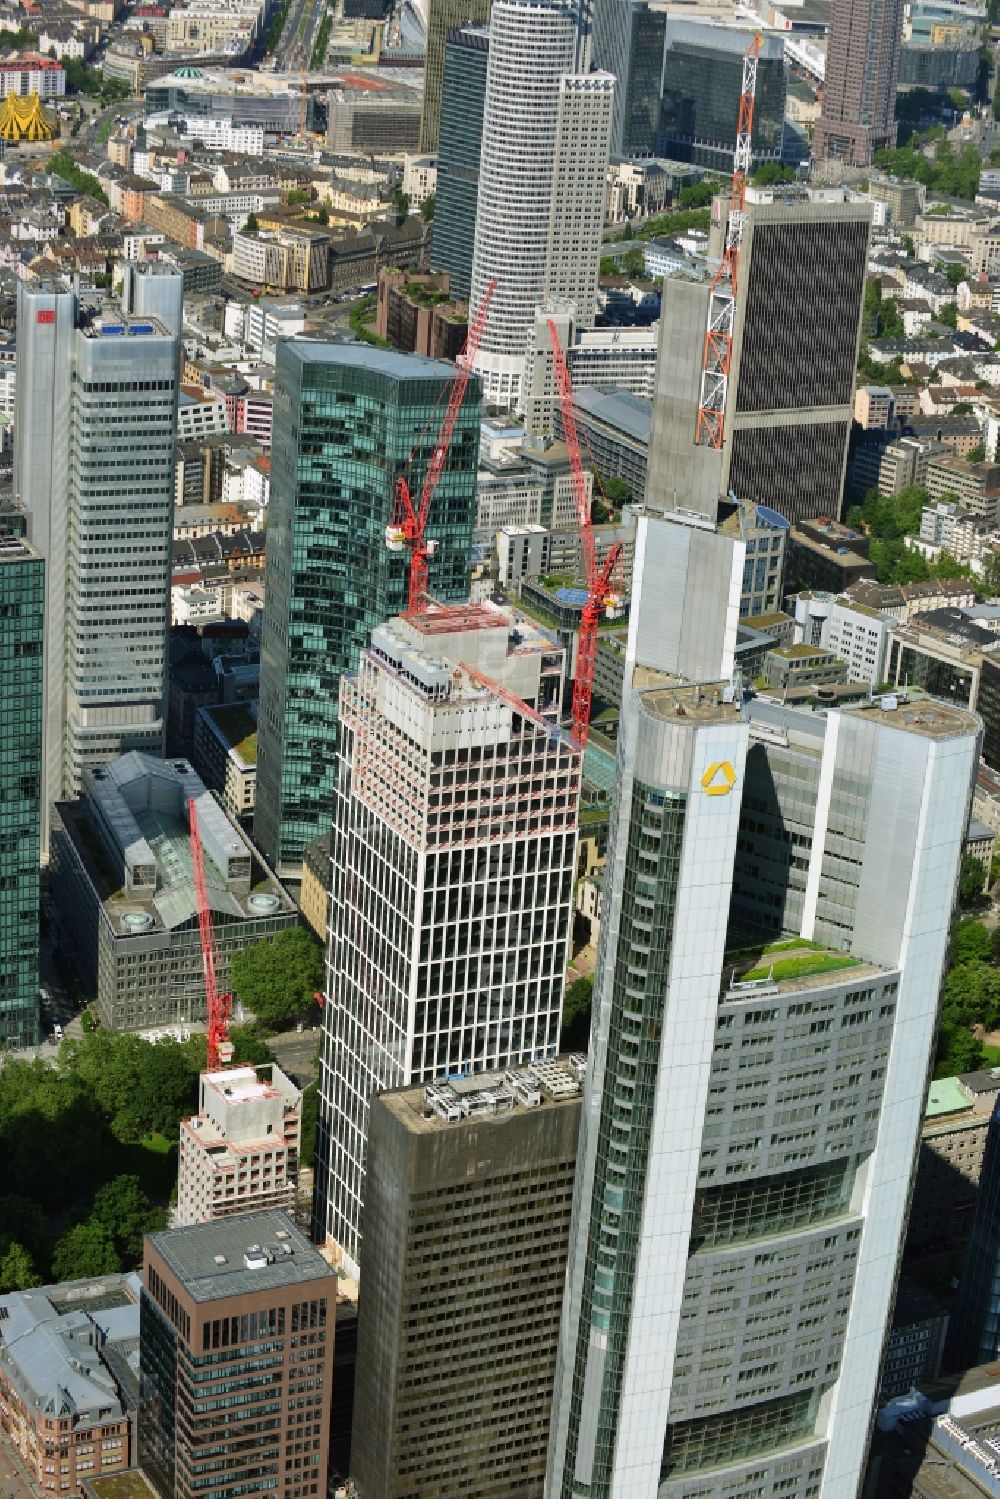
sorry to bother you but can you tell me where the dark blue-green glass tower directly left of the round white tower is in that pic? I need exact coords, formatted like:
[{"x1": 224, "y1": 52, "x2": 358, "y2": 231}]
[{"x1": 430, "y1": 24, "x2": 490, "y2": 301}]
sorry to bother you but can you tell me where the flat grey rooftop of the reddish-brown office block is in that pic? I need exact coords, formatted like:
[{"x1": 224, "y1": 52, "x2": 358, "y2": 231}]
[{"x1": 148, "y1": 1213, "x2": 337, "y2": 1301}]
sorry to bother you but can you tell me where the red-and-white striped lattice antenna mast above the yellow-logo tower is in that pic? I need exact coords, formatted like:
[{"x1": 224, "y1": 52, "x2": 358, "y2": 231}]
[{"x1": 694, "y1": 34, "x2": 763, "y2": 448}]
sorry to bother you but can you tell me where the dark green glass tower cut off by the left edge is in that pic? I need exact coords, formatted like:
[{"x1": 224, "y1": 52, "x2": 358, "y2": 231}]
[{"x1": 0, "y1": 535, "x2": 45, "y2": 1051}]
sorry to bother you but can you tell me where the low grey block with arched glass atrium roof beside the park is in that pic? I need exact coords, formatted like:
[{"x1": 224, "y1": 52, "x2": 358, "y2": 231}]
[{"x1": 52, "y1": 751, "x2": 295, "y2": 1030}]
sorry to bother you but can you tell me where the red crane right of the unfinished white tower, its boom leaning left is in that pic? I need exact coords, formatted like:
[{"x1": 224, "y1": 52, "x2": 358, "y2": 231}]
[{"x1": 549, "y1": 318, "x2": 622, "y2": 750}]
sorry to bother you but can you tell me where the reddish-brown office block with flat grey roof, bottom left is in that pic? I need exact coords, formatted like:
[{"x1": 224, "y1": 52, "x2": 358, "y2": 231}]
[{"x1": 138, "y1": 1213, "x2": 337, "y2": 1499}]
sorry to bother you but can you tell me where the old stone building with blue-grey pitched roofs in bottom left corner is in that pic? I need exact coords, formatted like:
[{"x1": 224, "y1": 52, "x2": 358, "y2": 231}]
[{"x1": 0, "y1": 1276, "x2": 139, "y2": 1499}]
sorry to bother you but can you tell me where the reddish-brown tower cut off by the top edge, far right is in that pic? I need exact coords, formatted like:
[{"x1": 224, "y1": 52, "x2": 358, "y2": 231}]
[{"x1": 813, "y1": 0, "x2": 903, "y2": 166}]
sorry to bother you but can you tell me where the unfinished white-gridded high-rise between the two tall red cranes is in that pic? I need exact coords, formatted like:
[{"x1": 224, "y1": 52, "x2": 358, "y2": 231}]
[{"x1": 313, "y1": 604, "x2": 580, "y2": 1267}]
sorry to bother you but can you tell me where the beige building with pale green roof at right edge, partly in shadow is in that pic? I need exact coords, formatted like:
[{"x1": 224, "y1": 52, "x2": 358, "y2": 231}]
[{"x1": 906, "y1": 1073, "x2": 1000, "y2": 1259}]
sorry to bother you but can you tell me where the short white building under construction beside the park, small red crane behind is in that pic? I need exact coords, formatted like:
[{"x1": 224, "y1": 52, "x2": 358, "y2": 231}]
[{"x1": 174, "y1": 1063, "x2": 301, "y2": 1228}]
